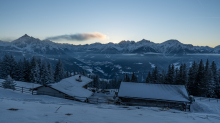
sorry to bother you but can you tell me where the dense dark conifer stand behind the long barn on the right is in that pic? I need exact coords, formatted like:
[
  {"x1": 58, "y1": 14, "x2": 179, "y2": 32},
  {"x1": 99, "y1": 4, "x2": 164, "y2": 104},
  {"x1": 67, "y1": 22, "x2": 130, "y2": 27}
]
[{"x1": 146, "y1": 59, "x2": 220, "y2": 97}]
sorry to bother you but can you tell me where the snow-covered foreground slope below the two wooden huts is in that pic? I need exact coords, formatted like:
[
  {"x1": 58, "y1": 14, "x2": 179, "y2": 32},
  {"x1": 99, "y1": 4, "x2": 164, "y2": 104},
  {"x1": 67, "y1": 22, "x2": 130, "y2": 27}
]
[{"x1": 0, "y1": 88, "x2": 220, "y2": 123}]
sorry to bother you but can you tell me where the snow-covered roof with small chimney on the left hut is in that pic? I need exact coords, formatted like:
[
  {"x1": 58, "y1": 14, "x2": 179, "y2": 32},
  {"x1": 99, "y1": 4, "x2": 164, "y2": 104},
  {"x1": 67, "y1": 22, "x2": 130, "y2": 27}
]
[{"x1": 51, "y1": 75, "x2": 92, "y2": 97}]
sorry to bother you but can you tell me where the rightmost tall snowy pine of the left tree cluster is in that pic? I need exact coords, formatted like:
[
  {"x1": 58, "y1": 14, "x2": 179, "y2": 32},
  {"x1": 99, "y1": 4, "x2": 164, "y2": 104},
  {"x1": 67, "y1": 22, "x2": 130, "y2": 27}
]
[{"x1": 54, "y1": 59, "x2": 65, "y2": 82}]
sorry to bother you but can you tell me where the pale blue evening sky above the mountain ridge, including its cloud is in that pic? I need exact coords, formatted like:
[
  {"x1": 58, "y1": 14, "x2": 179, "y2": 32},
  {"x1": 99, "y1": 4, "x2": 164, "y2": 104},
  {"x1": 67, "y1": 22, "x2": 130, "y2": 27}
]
[{"x1": 0, "y1": 0, "x2": 220, "y2": 47}]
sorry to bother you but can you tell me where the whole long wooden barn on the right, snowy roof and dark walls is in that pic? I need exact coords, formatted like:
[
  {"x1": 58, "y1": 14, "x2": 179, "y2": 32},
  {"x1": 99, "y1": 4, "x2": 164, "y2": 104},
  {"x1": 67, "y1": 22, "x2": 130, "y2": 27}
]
[{"x1": 118, "y1": 82, "x2": 190, "y2": 108}]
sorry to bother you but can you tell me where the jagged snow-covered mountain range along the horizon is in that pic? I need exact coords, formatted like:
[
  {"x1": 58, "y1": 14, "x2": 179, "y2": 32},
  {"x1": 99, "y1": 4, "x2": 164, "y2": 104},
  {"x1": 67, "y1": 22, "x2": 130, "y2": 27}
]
[{"x1": 0, "y1": 34, "x2": 220, "y2": 55}]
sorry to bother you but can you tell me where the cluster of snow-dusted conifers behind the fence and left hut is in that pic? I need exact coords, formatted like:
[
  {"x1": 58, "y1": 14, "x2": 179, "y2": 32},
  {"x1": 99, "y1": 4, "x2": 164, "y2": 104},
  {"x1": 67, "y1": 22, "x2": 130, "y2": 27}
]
[{"x1": 0, "y1": 54, "x2": 71, "y2": 85}]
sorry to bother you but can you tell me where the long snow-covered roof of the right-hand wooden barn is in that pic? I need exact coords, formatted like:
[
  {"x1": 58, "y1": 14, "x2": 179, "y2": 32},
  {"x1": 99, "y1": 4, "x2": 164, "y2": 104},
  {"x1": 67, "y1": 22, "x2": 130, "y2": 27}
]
[{"x1": 118, "y1": 82, "x2": 189, "y2": 102}]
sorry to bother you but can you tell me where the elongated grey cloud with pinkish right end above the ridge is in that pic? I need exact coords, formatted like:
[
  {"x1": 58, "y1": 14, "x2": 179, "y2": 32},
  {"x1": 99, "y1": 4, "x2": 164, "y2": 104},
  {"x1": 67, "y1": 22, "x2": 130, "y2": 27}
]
[{"x1": 46, "y1": 32, "x2": 107, "y2": 41}]
